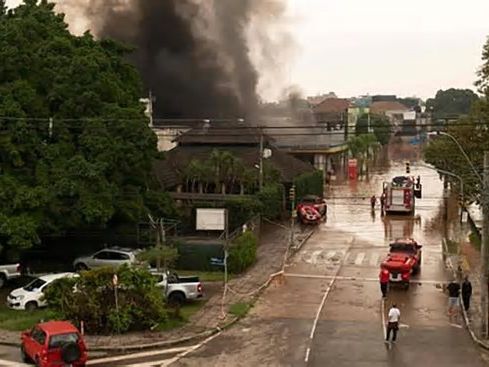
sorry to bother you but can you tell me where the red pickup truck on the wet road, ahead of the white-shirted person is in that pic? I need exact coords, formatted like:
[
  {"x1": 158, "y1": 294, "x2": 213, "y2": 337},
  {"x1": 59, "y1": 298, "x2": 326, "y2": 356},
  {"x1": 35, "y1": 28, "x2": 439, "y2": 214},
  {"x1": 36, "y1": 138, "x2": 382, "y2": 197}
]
[{"x1": 380, "y1": 238, "x2": 422, "y2": 289}]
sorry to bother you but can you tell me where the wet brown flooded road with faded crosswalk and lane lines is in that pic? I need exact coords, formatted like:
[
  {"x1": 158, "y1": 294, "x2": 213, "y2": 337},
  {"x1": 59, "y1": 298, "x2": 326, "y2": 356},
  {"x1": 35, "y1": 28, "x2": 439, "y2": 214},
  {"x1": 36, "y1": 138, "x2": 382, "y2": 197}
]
[{"x1": 171, "y1": 149, "x2": 487, "y2": 367}]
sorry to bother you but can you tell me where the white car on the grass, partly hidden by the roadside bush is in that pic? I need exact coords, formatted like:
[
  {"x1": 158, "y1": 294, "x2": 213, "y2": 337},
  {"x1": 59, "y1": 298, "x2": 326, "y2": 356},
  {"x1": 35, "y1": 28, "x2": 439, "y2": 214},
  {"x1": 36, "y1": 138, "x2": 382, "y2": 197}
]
[{"x1": 7, "y1": 273, "x2": 79, "y2": 311}]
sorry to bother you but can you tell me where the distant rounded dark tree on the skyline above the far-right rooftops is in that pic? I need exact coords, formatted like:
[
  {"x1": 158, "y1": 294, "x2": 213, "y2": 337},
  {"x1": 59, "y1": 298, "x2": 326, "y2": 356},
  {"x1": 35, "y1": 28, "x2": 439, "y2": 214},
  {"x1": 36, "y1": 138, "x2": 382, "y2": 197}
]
[{"x1": 426, "y1": 88, "x2": 479, "y2": 118}]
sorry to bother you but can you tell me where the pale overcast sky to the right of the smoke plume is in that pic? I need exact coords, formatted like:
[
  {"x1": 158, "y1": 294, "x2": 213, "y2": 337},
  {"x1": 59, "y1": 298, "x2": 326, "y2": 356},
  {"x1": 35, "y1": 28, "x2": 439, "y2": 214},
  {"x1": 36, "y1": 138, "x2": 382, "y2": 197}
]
[{"x1": 7, "y1": 0, "x2": 489, "y2": 98}]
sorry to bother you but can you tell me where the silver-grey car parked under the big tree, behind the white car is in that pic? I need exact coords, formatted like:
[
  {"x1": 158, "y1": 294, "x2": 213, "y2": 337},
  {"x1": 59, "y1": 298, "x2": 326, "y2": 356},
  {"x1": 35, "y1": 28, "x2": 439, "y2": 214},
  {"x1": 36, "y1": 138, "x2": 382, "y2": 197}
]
[{"x1": 73, "y1": 247, "x2": 141, "y2": 271}]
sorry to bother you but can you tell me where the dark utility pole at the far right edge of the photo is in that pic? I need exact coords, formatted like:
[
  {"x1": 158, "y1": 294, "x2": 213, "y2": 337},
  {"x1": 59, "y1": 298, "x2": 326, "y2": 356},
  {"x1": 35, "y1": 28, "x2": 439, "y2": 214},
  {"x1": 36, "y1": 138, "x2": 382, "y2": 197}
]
[{"x1": 480, "y1": 151, "x2": 489, "y2": 338}]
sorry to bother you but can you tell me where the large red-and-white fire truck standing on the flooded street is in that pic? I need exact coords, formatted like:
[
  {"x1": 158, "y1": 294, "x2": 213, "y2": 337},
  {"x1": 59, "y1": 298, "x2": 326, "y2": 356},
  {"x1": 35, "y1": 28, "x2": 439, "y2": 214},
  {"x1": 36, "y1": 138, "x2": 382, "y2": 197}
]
[{"x1": 383, "y1": 176, "x2": 421, "y2": 214}]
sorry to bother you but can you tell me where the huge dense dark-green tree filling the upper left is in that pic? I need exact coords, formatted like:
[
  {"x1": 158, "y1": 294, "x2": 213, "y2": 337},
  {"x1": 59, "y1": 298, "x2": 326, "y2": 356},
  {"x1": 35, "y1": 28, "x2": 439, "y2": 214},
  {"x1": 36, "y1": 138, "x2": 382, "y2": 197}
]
[{"x1": 0, "y1": 0, "x2": 168, "y2": 258}]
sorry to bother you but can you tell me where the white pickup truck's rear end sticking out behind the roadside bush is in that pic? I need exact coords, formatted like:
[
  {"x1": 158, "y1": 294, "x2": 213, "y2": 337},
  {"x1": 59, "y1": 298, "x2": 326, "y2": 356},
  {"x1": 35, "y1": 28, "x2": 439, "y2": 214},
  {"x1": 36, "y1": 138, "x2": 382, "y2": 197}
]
[{"x1": 151, "y1": 270, "x2": 204, "y2": 304}]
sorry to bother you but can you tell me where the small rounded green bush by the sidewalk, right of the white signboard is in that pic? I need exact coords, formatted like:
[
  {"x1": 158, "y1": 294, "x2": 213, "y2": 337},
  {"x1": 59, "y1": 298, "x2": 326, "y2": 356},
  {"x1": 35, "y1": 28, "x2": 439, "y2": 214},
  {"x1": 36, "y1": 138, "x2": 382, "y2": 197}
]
[{"x1": 228, "y1": 231, "x2": 258, "y2": 273}]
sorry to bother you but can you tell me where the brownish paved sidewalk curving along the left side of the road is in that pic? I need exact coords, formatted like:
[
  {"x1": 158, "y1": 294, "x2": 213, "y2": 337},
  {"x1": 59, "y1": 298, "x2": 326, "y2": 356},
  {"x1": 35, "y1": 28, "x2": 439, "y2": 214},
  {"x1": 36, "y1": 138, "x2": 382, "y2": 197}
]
[{"x1": 0, "y1": 223, "x2": 311, "y2": 351}]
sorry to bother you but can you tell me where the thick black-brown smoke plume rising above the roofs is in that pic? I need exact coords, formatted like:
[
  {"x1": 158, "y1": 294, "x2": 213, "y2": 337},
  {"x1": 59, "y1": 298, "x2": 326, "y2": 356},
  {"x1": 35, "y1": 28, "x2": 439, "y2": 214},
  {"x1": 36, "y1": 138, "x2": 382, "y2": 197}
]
[{"x1": 58, "y1": 0, "x2": 282, "y2": 118}]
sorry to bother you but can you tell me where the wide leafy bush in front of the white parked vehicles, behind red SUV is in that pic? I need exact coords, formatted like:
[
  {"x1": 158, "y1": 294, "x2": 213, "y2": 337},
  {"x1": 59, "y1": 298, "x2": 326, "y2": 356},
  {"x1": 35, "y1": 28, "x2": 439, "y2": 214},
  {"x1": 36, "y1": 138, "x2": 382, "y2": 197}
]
[{"x1": 45, "y1": 266, "x2": 167, "y2": 334}]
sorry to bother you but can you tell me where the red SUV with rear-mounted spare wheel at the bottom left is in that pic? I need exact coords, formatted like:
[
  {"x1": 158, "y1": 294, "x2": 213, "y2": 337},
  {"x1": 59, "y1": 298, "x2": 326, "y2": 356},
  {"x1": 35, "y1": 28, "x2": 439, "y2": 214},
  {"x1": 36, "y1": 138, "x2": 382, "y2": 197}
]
[{"x1": 20, "y1": 321, "x2": 88, "y2": 367}]
